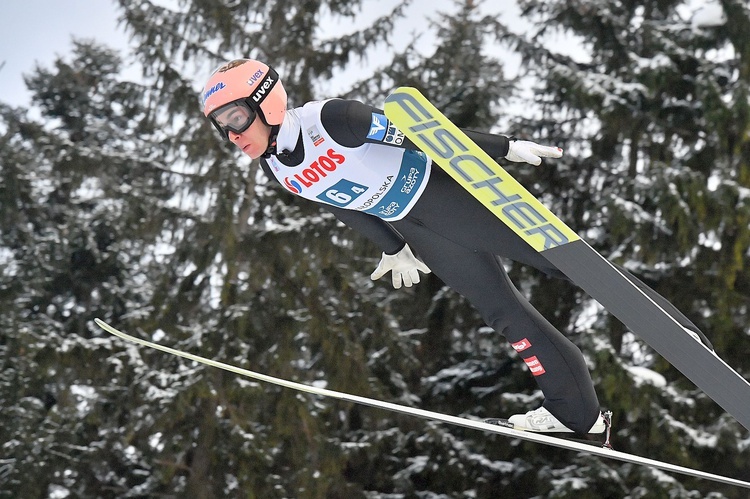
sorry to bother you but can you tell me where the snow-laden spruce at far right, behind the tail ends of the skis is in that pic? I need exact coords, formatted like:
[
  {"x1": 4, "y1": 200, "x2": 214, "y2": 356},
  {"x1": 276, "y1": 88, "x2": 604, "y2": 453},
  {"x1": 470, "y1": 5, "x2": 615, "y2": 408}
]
[{"x1": 496, "y1": 0, "x2": 750, "y2": 494}]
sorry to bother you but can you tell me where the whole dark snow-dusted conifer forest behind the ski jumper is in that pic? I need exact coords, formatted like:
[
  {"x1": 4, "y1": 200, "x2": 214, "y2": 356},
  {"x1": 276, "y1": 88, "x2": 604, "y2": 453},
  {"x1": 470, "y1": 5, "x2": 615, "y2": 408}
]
[{"x1": 0, "y1": 0, "x2": 750, "y2": 499}]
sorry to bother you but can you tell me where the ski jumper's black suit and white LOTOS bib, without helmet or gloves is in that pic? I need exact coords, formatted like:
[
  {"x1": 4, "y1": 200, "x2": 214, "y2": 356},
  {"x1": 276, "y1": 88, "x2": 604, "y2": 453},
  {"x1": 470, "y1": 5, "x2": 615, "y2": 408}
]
[{"x1": 261, "y1": 99, "x2": 697, "y2": 433}]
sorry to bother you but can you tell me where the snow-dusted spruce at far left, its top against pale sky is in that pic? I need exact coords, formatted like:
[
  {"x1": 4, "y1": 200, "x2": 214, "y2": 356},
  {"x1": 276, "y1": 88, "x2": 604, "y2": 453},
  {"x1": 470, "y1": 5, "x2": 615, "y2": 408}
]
[{"x1": 0, "y1": 42, "x2": 207, "y2": 497}]
